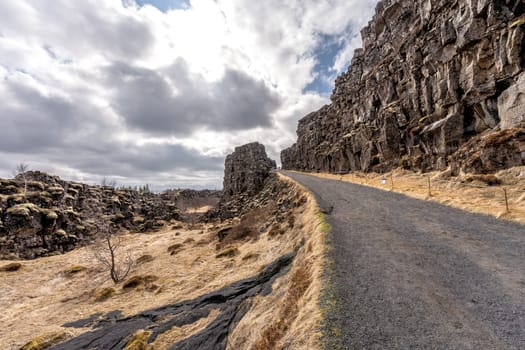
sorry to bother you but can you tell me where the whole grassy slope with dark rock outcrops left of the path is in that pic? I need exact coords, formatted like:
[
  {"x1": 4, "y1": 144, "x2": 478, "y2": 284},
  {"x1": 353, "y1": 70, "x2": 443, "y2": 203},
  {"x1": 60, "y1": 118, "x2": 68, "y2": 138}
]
[{"x1": 0, "y1": 146, "x2": 325, "y2": 350}]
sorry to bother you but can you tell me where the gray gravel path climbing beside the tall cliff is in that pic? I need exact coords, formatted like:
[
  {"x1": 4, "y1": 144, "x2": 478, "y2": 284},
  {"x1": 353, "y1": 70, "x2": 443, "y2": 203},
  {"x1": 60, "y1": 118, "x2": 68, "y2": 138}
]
[{"x1": 283, "y1": 172, "x2": 525, "y2": 350}]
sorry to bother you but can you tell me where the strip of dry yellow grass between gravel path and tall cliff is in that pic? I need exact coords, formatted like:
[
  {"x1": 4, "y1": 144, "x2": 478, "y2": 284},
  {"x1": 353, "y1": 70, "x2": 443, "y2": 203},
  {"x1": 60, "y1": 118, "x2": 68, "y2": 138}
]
[{"x1": 302, "y1": 166, "x2": 525, "y2": 224}]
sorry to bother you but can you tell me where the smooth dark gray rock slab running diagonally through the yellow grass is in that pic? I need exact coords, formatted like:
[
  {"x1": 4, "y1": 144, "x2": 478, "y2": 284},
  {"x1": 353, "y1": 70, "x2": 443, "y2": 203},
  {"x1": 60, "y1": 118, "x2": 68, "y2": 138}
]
[{"x1": 52, "y1": 253, "x2": 294, "y2": 350}]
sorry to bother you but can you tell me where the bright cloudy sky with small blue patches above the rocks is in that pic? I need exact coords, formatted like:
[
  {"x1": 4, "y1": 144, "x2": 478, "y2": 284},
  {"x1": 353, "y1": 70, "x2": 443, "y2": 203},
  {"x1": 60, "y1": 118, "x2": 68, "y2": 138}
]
[{"x1": 0, "y1": 0, "x2": 377, "y2": 189}]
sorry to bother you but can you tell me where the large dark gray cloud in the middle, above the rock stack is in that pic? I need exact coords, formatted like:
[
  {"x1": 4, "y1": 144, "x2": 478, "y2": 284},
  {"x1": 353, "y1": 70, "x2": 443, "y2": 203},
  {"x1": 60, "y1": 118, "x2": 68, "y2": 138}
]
[{"x1": 107, "y1": 59, "x2": 281, "y2": 135}]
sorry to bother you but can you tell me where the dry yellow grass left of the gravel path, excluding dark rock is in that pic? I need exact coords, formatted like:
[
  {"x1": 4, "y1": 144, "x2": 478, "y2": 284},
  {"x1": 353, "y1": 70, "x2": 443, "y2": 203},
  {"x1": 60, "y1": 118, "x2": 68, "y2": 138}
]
[{"x1": 0, "y1": 176, "x2": 324, "y2": 349}]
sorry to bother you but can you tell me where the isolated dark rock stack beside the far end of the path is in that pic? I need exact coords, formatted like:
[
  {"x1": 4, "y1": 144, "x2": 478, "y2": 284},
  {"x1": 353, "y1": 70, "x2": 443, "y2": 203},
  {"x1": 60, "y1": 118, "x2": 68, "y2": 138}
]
[{"x1": 206, "y1": 142, "x2": 276, "y2": 220}]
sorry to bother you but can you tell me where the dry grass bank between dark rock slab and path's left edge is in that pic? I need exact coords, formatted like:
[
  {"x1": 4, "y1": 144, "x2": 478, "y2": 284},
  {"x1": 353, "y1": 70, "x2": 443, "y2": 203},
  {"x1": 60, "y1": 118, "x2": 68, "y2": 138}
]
[{"x1": 227, "y1": 175, "x2": 326, "y2": 350}]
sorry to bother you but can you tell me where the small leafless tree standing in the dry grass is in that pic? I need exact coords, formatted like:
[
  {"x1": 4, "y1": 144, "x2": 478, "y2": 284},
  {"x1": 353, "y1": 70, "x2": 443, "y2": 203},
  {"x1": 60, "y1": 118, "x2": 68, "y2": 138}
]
[{"x1": 91, "y1": 227, "x2": 134, "y2": 284}]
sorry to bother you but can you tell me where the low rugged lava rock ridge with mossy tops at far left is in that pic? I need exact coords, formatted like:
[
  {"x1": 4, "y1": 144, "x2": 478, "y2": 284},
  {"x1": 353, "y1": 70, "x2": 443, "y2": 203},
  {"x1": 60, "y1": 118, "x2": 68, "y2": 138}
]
[{"x1": 0, "y1": 171, "x2": 179, "y2": 259}]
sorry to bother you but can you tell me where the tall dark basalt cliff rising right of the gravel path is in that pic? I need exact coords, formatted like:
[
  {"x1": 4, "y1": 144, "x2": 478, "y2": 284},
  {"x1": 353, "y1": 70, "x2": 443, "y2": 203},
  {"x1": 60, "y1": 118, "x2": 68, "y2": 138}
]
[{"x1": 281, "y1": 0, "x2": 525, "y2": 172}]
